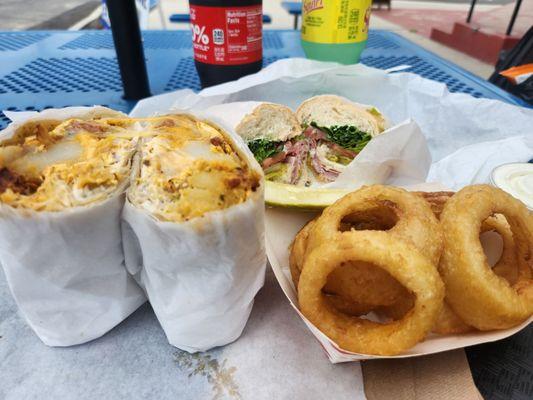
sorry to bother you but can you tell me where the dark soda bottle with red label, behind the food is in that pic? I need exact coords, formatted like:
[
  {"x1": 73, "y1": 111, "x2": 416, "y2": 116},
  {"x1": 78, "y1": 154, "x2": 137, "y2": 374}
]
[{"x1": 189, "y1": 0, "x2": 263, "y2": 87}]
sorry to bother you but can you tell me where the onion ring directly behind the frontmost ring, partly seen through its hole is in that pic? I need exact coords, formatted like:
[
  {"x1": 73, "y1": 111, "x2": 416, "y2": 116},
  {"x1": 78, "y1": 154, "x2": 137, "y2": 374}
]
[{"x1": 290, "y1": 185, "x2": 442, "y2": 315}]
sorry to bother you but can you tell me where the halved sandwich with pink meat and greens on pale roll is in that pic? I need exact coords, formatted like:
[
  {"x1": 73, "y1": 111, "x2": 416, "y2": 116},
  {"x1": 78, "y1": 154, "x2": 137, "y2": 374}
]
[{"x1": 236, "y1": 95, "x2": 386, "y2": 187}]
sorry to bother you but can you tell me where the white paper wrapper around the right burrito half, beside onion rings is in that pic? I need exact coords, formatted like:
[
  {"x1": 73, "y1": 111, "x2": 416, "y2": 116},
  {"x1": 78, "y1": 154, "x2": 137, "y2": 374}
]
[{"x1": 123, "y1": 114, "x2": 266, "y2": 352}]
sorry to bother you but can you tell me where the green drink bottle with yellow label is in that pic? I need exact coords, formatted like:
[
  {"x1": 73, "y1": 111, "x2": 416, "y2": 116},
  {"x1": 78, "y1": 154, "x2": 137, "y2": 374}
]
[{"x1": 302, "y1": 0, "x2": 372, "y2": 64}]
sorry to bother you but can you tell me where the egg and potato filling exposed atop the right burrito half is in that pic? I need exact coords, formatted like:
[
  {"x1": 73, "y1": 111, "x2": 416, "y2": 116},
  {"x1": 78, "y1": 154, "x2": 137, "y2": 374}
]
[{"x1": 124, "y1": 116, "x2": 260, "y2": 222}]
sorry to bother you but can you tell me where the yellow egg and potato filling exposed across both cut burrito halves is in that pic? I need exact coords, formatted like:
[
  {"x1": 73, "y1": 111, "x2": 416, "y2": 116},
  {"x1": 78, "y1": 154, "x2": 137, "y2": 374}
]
[{"x1": 0, "y1": 115, "x2": 260, "y2": 222}]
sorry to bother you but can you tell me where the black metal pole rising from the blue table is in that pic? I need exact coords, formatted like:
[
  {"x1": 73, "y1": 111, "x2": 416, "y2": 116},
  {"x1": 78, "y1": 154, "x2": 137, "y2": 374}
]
[{"x1": 106, "y1": 0, "x2": 150, "y2": 100}]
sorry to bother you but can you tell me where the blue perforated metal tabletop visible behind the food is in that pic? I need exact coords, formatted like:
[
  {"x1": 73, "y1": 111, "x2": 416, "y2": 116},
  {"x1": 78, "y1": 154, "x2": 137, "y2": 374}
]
[{"x1": 0, "y1": 30, "x2": 518, "y2": 134}]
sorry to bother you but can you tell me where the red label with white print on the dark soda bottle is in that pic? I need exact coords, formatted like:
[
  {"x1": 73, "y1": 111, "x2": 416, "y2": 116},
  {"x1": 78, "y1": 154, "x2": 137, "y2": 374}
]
[{"x1": 190, "y1": 5, "x2": 263, "y2": 65}]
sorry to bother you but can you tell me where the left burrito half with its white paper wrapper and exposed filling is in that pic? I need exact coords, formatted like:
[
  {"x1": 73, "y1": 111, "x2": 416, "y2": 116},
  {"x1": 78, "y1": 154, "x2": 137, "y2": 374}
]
[{"x1": 0, "y1": 107, "x2": 145, "y2": 346}]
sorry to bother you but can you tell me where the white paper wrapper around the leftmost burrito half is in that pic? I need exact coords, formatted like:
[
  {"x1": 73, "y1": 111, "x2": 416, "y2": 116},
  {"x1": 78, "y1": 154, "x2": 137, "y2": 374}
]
[{"x1": 0, "y1": 107, "x2": 146, "y2": 346}]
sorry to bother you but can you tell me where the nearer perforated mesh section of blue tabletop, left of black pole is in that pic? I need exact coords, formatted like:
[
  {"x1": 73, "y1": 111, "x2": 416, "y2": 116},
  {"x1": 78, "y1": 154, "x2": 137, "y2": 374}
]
[{"x1": 0, "y1": 57, "x2": 122, "y2": 94}]
